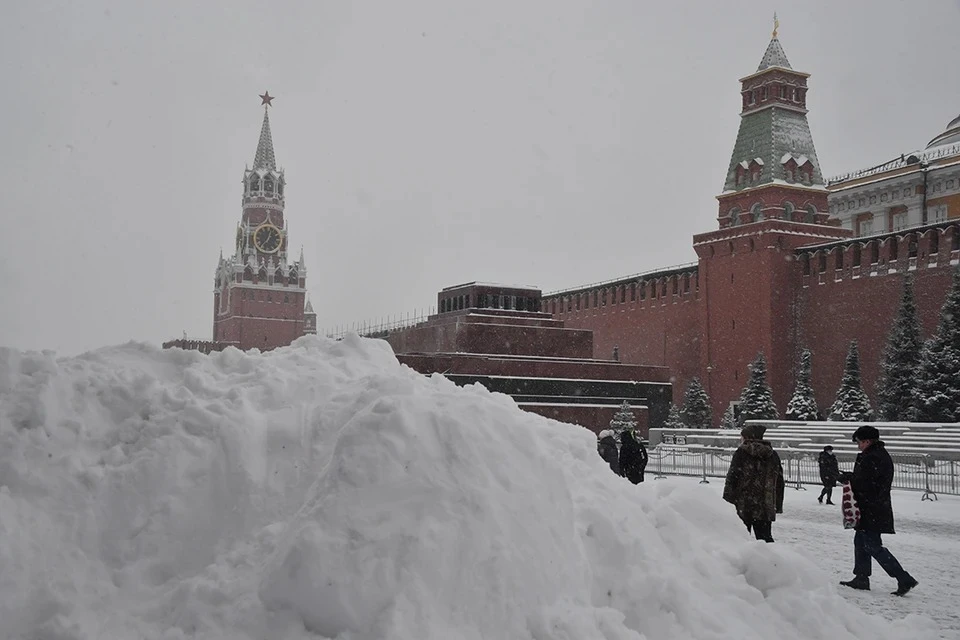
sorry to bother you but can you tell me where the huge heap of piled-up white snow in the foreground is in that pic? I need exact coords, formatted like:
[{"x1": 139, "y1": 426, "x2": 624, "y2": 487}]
[{"x1": 0, "y1": 336, "x2": 932, "y2": 640}]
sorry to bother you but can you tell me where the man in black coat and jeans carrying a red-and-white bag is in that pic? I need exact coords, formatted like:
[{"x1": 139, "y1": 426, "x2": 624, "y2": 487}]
[{"x1": 840, "y1": 424, "x2": 917, "y2": 596}]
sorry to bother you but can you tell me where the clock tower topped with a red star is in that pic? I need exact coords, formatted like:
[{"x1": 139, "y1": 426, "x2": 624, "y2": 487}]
[{"x1": 213, "y1": 93, "x2": 316, "y2": 350}]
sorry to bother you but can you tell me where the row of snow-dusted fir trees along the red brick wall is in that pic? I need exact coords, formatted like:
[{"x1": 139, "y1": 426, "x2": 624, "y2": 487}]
[{"x1": 665, "y1": 269, "x2": 960, "y2": 429}]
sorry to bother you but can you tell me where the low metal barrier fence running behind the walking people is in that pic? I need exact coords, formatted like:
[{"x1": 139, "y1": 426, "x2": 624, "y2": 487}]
[{"x1": 647, "y1": 445, "x2": 960, "y2": 500}]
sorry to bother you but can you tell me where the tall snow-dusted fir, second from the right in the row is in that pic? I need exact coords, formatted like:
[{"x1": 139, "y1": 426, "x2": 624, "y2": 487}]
[{"x1": 877, "y1": 274, "x2": 923, "y2": 420}]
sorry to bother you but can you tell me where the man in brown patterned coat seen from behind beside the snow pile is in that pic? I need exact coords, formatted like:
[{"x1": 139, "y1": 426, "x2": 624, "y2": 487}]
[{"x1": 723, "y1": 424, "x2": 786, "y2": 542}]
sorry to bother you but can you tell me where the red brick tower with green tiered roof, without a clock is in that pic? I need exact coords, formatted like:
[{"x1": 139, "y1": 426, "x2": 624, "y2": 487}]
[{"x1": 694, "y1": 29, "x2": 849, "y2": 416}]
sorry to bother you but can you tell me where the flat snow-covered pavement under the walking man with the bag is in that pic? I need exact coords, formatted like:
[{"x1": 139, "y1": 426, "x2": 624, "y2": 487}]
[{"x1": 664, "y1": 476, "x2": 960, "y2": 640}]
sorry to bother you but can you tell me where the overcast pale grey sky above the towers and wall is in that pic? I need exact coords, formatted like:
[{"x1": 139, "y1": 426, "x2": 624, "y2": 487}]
[{"x1": 0, "y1": 0, "x2": 960, "y2": 354}]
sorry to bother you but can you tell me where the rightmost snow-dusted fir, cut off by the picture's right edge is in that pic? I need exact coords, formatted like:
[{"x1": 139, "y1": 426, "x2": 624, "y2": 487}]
[{"x1": 913, "y1": 269, "x2": 960, "y2": 422}]
